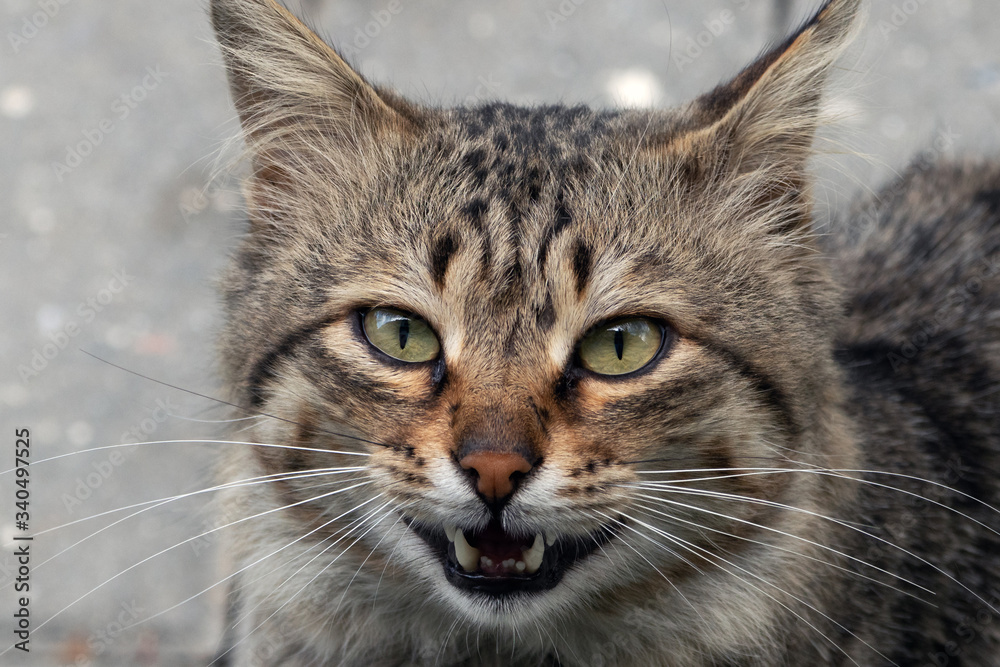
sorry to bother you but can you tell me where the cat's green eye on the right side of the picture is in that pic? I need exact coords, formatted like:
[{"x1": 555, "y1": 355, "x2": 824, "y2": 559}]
[{"x1": 580, "y1": 317, "x2": 663, "y2": 375}]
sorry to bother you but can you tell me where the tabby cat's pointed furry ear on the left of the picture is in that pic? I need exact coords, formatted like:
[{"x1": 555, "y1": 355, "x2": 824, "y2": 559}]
[{"x1": 211, "y1": 0, "x2": 418, "y2": 222}]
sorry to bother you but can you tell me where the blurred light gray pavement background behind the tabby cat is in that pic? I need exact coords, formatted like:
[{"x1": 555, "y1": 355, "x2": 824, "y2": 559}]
[{"x1": 0, "y1": 0, "x2": 1000, "y2": 666}]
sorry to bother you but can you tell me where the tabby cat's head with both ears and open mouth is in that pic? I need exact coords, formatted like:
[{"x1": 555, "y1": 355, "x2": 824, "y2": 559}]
[{"x1": 212, "y1": 0, "x2": 859, "y2": 636}]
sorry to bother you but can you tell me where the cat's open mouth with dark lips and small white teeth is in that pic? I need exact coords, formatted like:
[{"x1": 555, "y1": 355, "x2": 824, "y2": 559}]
[{"x1": 406, "y1": 519, "x2": 614, "y2": 596}]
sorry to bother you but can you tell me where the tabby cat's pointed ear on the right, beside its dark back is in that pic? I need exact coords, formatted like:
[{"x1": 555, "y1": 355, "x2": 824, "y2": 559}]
[{"x1": 668, "y1": 0, "x2": 861, "y2": 232}]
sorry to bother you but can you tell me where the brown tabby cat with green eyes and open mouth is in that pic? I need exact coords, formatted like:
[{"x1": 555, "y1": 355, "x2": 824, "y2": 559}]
[{"x1": 205, "y1": 0, "x2": 1000, "y2": 667}]
